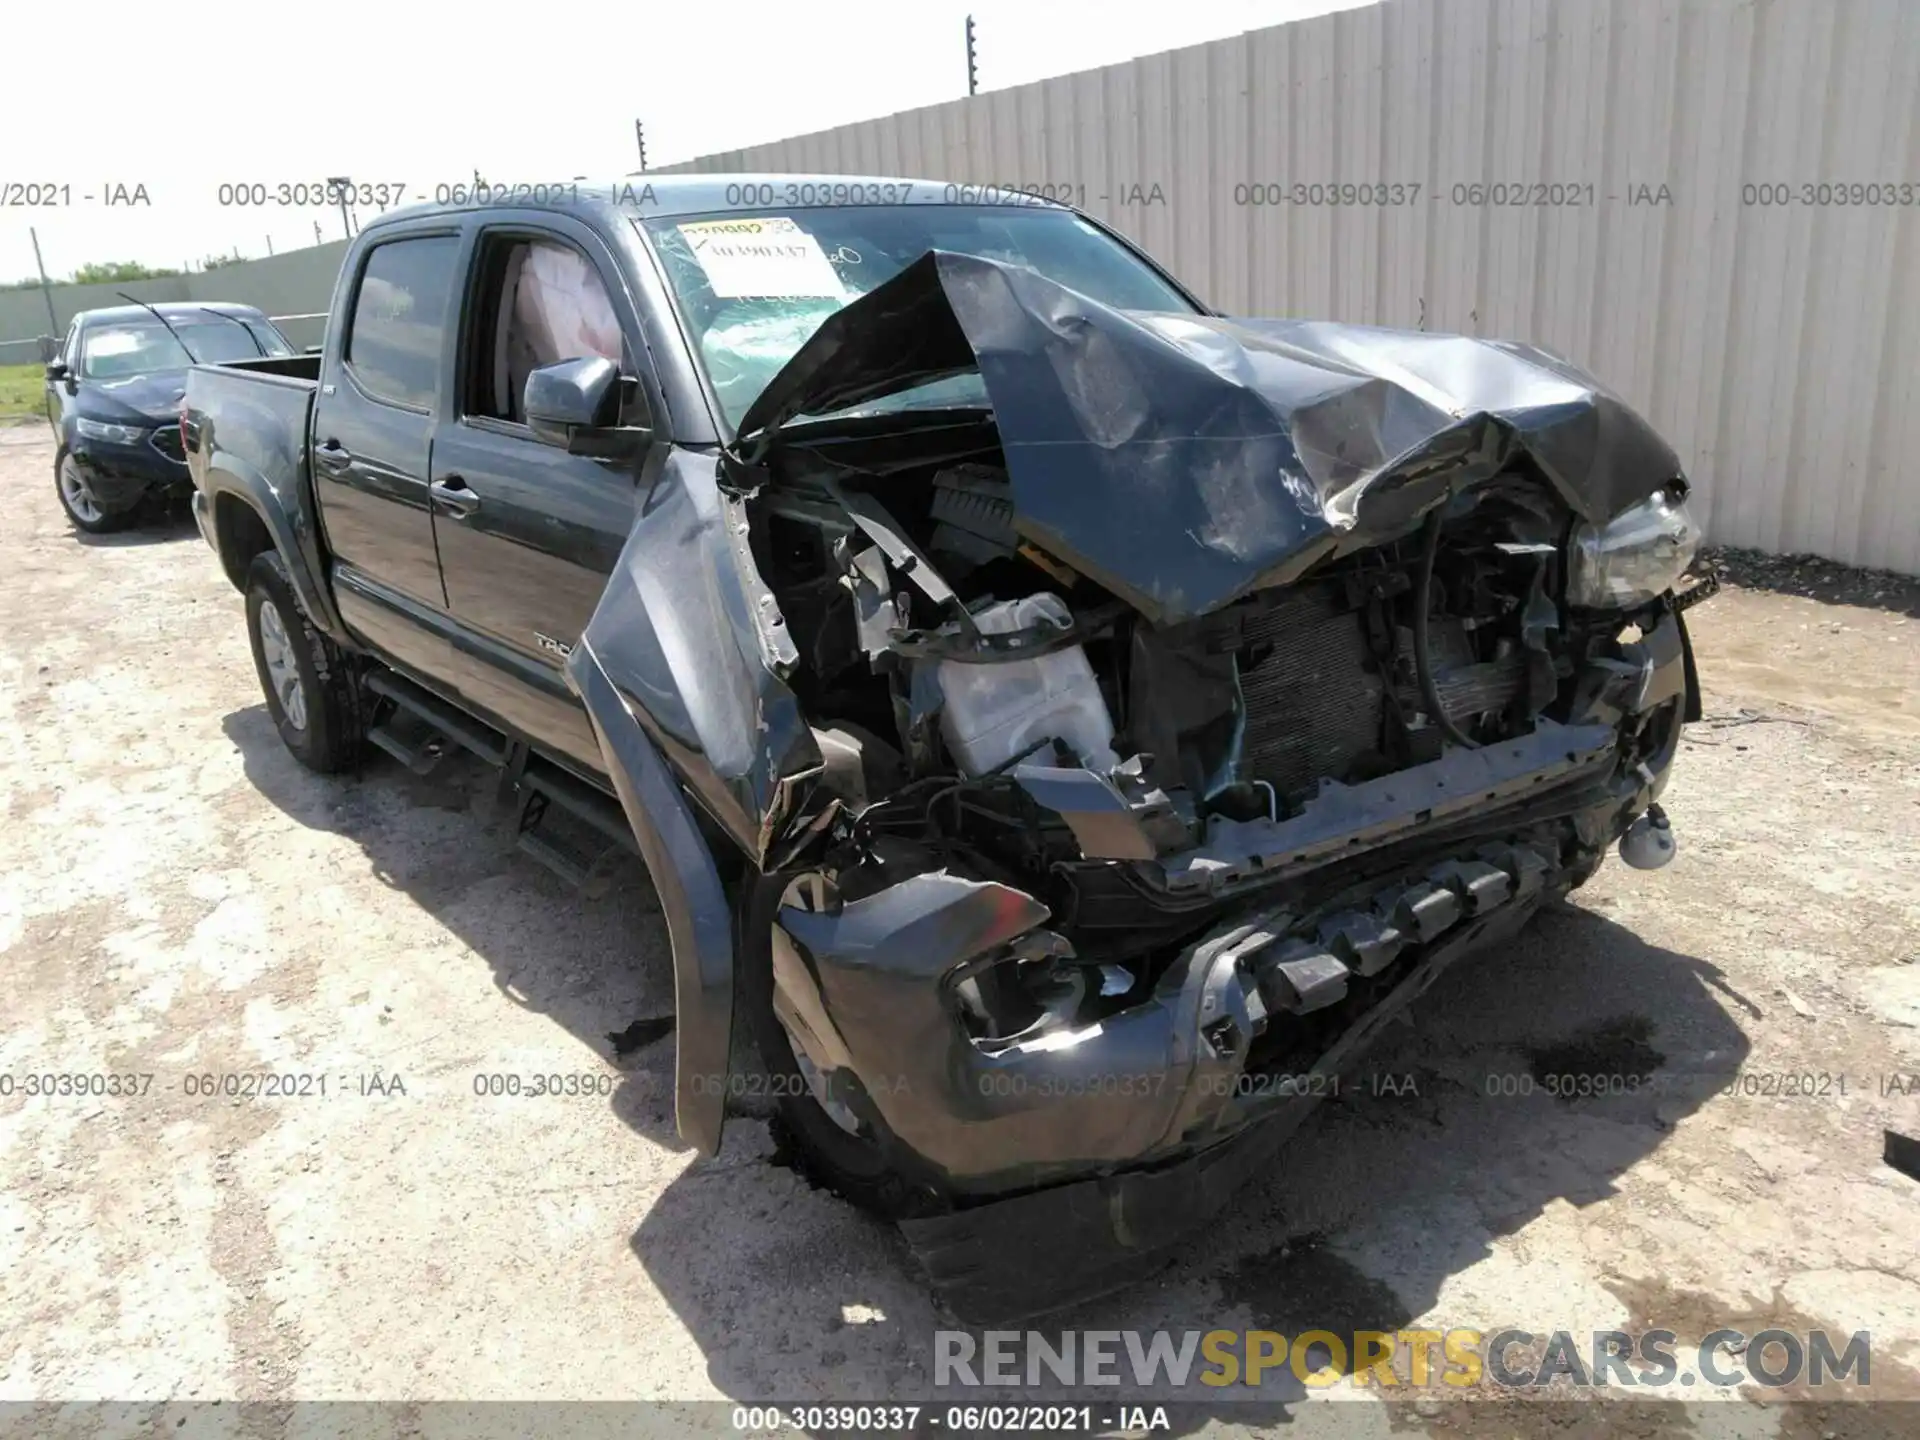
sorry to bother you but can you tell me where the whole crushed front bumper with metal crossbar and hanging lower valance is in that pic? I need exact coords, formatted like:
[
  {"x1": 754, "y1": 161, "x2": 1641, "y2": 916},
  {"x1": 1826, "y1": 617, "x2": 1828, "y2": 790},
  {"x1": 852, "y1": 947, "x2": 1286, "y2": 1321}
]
[{"x1": 774, "y1": 612, "x2": 1697, "y2": 1313}]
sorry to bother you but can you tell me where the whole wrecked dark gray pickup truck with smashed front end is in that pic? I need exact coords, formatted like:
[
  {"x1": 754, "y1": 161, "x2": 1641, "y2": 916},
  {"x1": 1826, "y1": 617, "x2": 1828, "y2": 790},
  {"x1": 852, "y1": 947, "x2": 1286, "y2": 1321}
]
[{"x1": 182, "y1": 177, "x2": 1703, "y2": 1319}]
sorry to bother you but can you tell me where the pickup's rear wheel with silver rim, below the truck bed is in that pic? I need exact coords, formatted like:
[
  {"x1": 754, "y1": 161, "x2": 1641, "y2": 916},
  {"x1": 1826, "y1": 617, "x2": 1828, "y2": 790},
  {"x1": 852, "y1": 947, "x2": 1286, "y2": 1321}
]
[{"x1": 246, "y1": 551, "x2": 367, "y2": 776}]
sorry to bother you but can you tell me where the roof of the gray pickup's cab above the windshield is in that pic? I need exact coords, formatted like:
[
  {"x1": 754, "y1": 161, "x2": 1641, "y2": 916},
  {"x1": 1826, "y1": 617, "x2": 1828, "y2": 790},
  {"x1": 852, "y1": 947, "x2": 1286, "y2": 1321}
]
[{"x1": 367, "y1": 171, "x2": 1052, "y2": 228}]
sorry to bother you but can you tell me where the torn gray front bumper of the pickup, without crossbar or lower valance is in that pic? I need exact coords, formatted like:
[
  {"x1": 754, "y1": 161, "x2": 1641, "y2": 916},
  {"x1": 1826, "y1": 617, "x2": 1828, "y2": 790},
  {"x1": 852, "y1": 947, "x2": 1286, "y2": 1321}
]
[{"x1": 774, "y1": 817, "x2": 1611, "y2": 1204}]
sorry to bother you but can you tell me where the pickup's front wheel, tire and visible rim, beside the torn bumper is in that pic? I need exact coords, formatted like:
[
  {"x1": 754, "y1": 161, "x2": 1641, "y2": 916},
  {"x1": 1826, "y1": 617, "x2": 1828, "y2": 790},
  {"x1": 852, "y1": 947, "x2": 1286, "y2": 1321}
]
[{"x1": 739, "y1": 874, "x2": 947, "y2": 1219}]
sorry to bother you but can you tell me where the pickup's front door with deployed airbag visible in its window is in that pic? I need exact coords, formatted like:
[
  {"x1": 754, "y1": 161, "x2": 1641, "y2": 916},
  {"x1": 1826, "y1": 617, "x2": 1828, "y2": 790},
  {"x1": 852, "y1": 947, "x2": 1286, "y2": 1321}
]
[{"x1": 432, "y1": 211, "x2": 657, "y2": 774}]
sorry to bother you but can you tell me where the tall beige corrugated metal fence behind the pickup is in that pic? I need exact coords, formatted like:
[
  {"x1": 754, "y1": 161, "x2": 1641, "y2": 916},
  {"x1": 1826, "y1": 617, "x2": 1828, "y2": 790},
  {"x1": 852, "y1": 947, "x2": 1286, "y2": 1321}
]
[{"x1": 680, "y1": 0, "x2": 1920, "y2": 572}]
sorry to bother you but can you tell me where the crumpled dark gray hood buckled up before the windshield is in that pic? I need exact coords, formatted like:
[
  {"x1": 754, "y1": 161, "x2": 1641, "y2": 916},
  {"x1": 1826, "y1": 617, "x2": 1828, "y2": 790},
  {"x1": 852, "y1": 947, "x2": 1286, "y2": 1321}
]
[{"x1": 739, "y1": 250, "x2": 1680, "y2": 624}]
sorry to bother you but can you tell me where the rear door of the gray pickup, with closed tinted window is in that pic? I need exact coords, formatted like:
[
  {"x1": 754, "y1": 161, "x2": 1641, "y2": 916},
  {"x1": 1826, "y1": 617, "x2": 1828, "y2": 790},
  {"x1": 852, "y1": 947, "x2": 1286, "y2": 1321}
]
[{"x1": 311, "y1": 225, "x2": 461, "y2": 680}]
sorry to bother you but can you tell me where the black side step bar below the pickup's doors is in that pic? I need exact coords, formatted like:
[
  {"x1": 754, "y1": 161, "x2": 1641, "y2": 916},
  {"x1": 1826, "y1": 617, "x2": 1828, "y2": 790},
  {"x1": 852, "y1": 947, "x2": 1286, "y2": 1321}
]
[{"x1": 367, "y1": 670, "x2": 639, "y2": 895}]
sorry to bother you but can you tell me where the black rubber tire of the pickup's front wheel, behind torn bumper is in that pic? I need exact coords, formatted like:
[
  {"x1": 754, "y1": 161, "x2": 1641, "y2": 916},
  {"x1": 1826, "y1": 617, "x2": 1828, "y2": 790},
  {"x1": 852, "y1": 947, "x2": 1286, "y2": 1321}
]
[{"x1": 735, "y1": 874, "x2": 948, "y2": 1221}]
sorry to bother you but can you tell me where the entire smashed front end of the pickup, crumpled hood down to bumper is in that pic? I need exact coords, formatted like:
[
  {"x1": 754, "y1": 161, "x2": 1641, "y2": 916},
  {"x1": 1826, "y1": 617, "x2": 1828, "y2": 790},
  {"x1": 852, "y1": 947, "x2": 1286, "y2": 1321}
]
[{"x1": 633, "y1": 252, "x2": 1699, "y2": 1309}]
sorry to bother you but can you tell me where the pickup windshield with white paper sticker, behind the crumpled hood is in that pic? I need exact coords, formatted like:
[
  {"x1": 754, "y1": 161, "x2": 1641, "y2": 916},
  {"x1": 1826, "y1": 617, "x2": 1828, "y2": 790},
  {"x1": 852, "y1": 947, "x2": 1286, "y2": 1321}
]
[{"x1": 641, "y1": 205, "x2": 1194, "y2": 426}]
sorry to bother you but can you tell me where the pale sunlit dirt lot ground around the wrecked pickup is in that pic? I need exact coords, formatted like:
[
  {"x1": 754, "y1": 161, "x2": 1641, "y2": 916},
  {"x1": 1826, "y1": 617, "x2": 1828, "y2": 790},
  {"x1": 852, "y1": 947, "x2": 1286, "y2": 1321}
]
[{"x1": 0, "y1": 430, "x2": 1920, "y2": 1436}]
